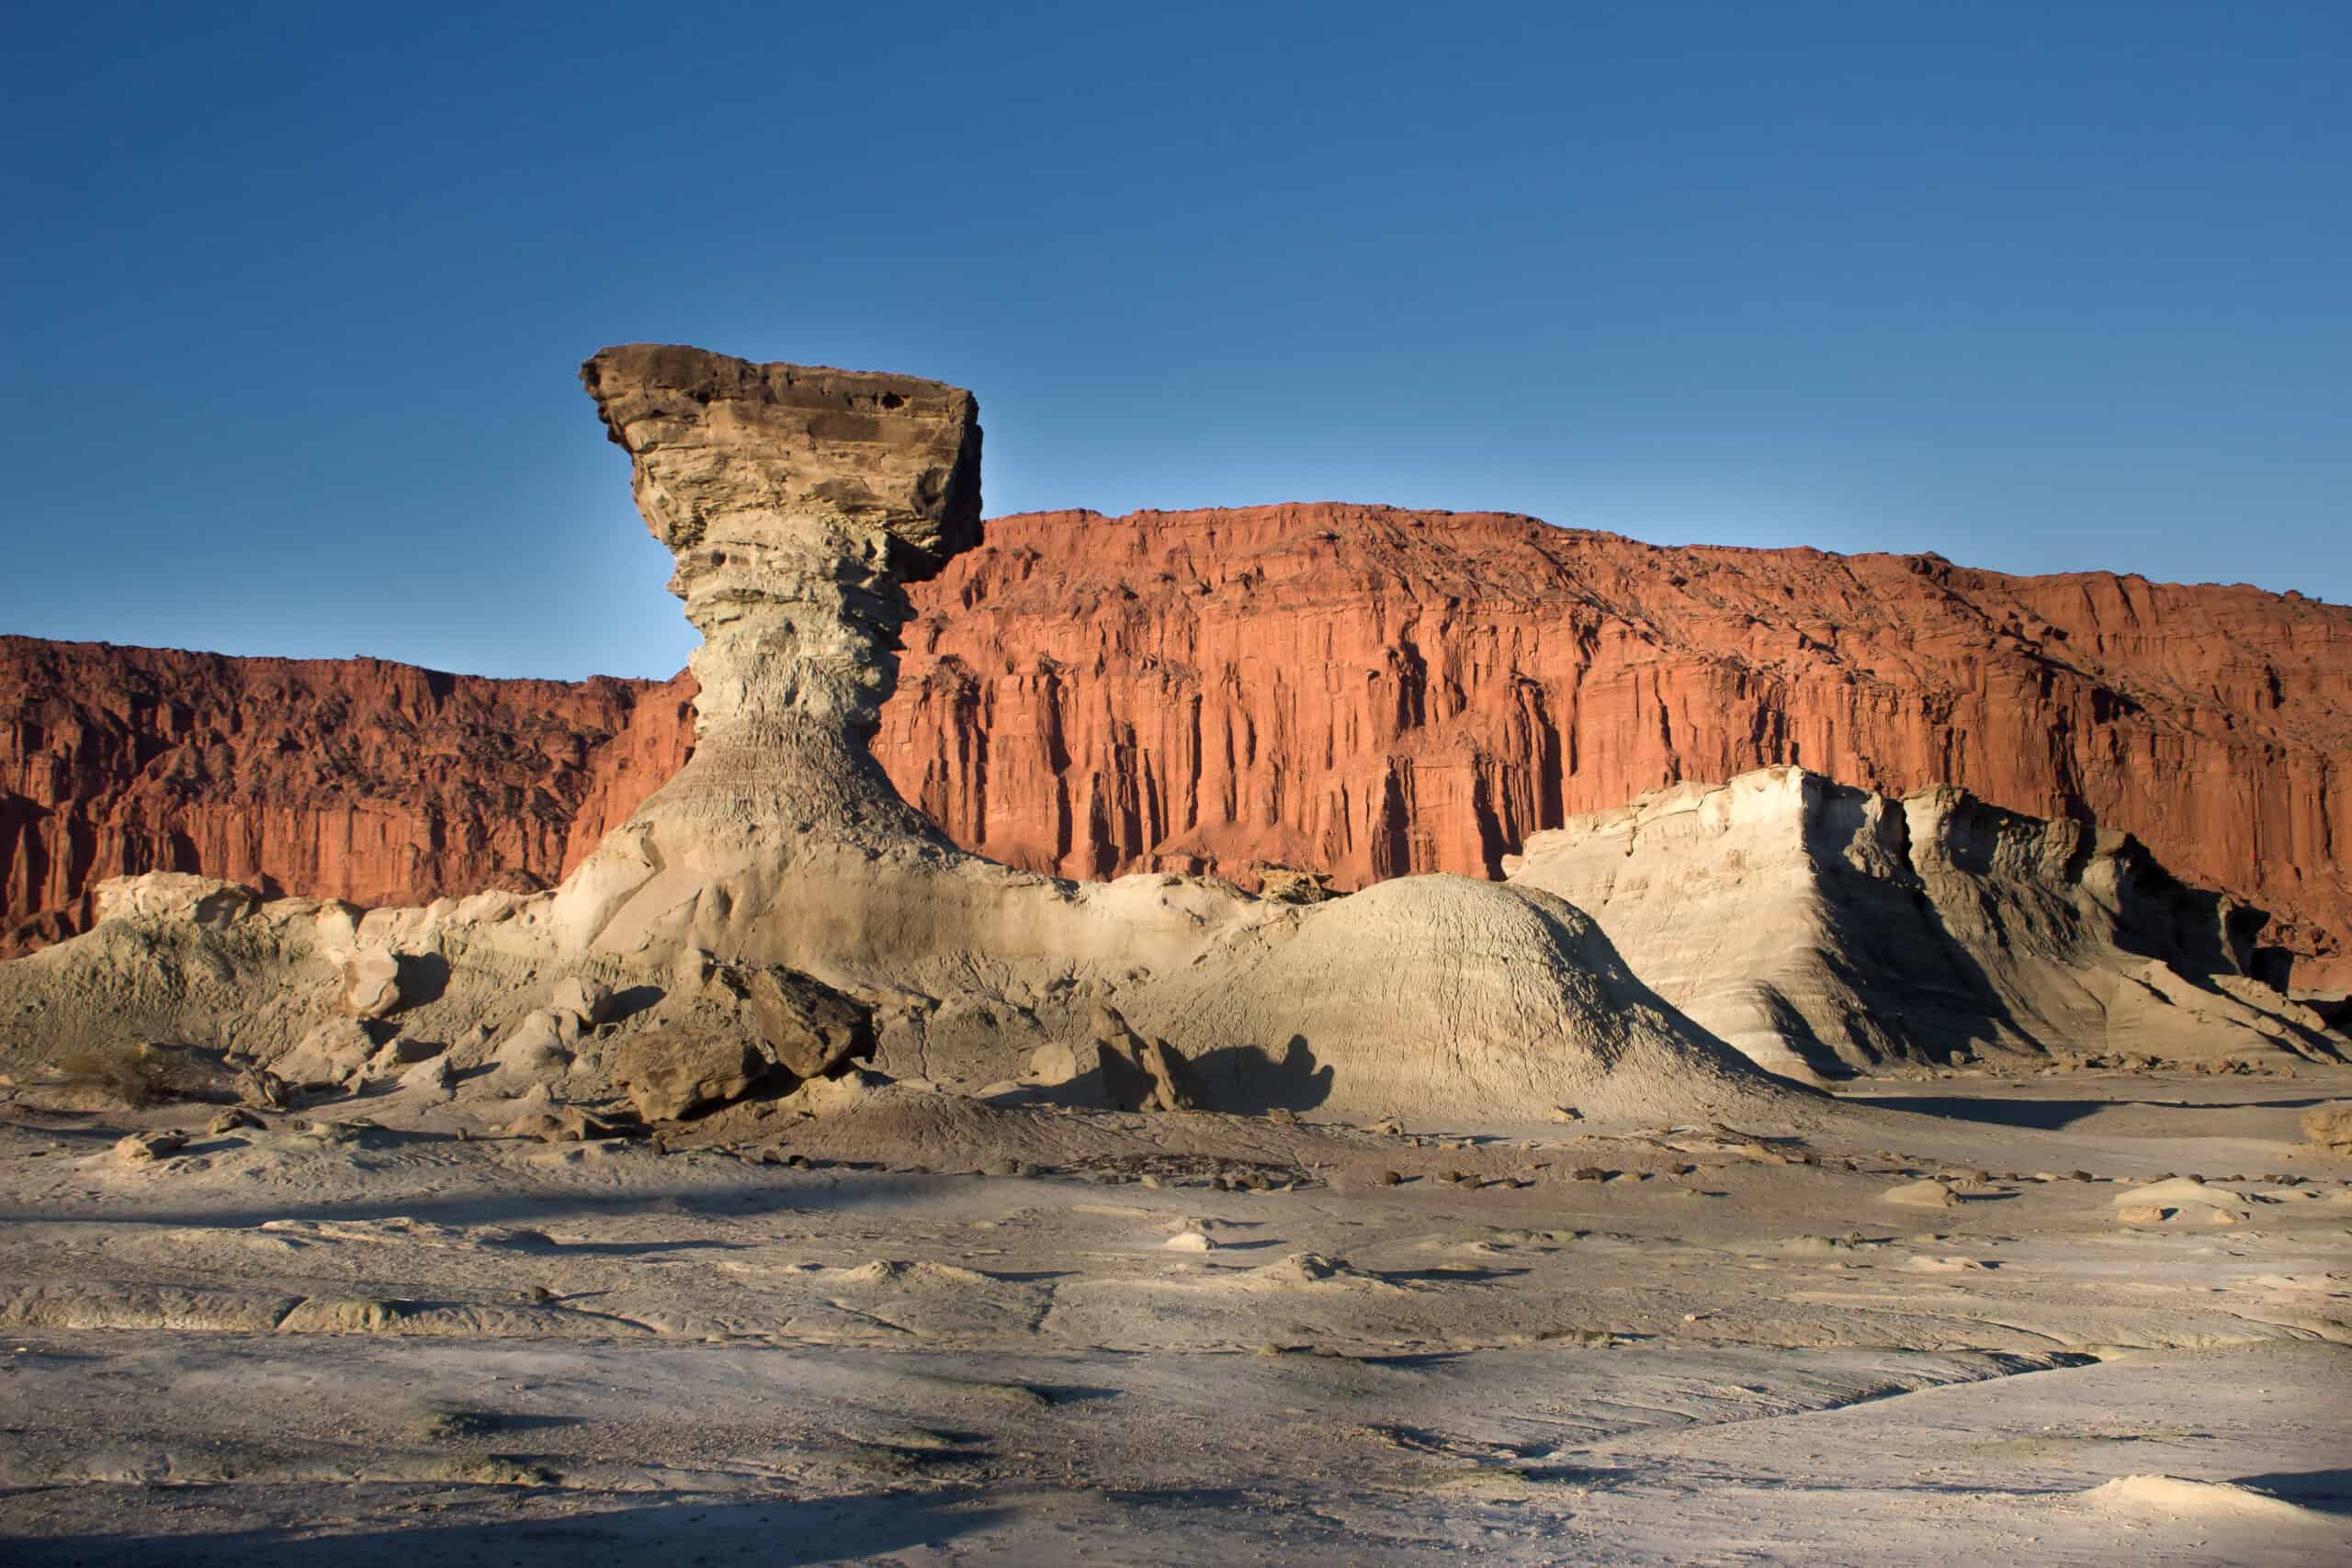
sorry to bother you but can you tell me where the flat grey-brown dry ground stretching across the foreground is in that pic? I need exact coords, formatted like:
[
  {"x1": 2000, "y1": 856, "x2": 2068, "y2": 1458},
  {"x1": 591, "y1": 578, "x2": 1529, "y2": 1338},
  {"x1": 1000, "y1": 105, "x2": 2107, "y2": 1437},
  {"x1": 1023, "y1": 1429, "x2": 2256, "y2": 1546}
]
[{"x1": 0, "y1": 1075, "x2": 2352, "y2": 1568}]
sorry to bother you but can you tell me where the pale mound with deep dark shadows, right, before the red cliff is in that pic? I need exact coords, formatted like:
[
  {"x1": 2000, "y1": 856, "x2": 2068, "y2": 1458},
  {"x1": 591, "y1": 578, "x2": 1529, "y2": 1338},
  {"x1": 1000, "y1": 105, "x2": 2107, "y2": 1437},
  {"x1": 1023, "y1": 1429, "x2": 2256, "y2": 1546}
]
[{"x1": 1503, "y1": 769, "x2": 2345, "y2": 1077}]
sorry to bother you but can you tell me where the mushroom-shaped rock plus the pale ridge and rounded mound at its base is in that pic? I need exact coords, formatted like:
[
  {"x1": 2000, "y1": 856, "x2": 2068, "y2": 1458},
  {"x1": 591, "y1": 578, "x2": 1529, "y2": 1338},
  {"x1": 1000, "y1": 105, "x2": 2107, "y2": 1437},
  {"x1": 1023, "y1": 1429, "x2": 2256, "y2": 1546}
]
[{"x1": 0, "y1": 345, "x2": 1818, "y2": 1122}]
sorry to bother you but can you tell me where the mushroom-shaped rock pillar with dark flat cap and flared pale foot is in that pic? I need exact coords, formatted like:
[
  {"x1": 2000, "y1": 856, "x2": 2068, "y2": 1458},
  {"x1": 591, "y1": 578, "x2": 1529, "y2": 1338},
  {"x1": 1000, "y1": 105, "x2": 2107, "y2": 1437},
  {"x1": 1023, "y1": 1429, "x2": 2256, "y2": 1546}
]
[{"x1": 553, "y1": 344, "x2": 1288, "y2": 992}]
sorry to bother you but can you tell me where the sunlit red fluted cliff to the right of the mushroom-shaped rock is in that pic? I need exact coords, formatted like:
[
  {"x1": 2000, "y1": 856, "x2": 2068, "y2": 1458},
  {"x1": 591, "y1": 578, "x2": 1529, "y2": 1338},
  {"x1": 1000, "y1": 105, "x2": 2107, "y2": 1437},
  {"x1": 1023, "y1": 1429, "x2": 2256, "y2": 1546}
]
[{"x1": 875, "y1": 505, "x2": 2352, "y2": 983}]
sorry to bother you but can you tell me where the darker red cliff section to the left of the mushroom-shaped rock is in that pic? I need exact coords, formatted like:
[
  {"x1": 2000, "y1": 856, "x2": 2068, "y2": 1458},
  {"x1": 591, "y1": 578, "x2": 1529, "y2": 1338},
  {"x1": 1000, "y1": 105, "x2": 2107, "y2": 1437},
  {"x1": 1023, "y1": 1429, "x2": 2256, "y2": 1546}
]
[{"x1": 0, "y1": 637, "x2": 692, "y2": 957}]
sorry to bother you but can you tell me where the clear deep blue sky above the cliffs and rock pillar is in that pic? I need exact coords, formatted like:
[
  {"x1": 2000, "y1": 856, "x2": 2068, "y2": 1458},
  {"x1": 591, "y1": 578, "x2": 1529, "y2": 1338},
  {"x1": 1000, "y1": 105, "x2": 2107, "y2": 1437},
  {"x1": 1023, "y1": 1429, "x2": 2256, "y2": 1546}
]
[{"x1": 0, "y1": 0, "x2": 2352, "y2": 677}]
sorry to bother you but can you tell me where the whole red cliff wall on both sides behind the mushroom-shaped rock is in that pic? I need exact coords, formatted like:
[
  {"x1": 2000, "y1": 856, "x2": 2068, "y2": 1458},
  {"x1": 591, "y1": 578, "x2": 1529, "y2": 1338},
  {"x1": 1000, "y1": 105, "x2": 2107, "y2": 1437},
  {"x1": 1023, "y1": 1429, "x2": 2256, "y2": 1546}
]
[{"x1": 0, "y1": 505, "x2": 2352, "y2": 987}]
